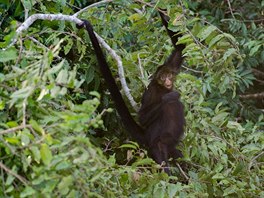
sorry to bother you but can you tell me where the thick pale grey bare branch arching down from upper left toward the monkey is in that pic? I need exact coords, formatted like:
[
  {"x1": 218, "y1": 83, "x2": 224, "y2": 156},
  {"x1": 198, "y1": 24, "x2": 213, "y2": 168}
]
[{"x1": 11, "y1": 12, "x2": 138, "y2": 110}]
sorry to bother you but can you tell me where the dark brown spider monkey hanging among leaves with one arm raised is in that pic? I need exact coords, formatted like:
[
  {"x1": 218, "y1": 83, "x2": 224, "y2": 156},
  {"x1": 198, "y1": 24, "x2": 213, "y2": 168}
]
[{"x1": 79, "y1": 13, "x2": 185, "y2": 173}]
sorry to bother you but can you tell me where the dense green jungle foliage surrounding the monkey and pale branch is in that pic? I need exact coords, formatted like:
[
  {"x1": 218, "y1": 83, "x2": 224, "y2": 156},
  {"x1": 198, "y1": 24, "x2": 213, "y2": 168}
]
[{"x1": 0, "y1": 0, "x2": 264, "y2": 198}]
